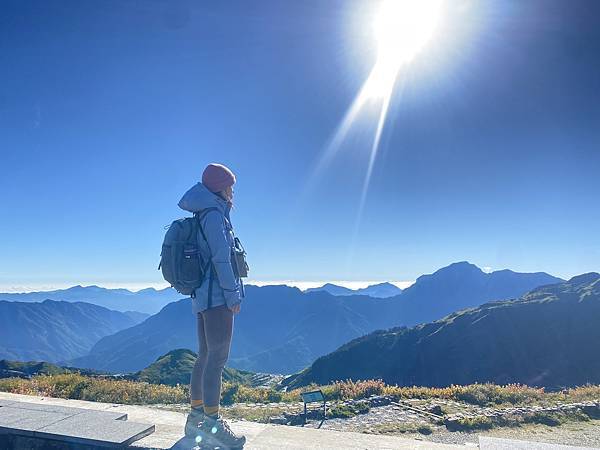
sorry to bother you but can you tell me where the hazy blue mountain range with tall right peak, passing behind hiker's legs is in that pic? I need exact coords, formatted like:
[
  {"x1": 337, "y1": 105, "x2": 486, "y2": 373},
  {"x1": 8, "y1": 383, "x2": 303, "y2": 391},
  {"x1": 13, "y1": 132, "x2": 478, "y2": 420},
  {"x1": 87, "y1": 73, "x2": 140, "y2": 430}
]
[{"x1": 66, "y1": 262, "x2": 562, "y2": 373}]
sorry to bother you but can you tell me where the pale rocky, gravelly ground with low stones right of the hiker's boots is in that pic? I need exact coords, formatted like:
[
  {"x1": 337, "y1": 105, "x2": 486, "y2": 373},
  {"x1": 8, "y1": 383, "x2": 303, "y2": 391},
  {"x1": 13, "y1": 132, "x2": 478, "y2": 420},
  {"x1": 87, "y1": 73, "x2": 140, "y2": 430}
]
[{"x1": 151, "y1": 397, "x2": 600, "y2": 448}]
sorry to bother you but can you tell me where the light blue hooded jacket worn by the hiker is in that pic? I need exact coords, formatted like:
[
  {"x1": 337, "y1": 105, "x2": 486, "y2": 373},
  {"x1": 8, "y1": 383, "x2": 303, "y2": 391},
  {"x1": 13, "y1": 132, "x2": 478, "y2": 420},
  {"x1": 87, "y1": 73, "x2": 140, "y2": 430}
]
[{"x1": 178, "y1": 183, "x2": 243, "y2": 314}]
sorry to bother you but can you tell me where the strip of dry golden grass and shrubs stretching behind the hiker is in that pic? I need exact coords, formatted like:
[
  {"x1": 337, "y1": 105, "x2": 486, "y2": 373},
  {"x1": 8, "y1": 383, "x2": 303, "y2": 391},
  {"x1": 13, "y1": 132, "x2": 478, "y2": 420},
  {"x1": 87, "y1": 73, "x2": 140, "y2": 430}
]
[{"x1": 0, "y1": 374, "x2": 600, "y2": 405}]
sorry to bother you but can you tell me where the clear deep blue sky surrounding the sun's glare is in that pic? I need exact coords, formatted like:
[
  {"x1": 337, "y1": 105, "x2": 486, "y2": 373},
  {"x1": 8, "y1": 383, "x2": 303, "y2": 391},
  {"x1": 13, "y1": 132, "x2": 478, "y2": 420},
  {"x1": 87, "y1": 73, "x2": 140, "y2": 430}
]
[{"x1": 0, "y1": 0, "x2": 600, "y2": 288}]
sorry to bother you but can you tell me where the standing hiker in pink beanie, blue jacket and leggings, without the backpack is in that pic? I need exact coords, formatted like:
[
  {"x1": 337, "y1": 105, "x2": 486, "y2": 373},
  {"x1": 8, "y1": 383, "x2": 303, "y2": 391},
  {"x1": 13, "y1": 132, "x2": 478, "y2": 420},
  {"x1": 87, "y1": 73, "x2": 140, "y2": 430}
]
[{"x1": 179, "y1": 164, "x2": 246, "y2": 448}]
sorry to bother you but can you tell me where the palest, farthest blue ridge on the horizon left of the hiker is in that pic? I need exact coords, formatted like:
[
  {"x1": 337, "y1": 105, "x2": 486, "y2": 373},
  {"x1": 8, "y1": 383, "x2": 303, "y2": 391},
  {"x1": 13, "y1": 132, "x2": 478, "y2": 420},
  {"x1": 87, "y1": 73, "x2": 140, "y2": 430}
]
[{"x1": 0, "y1": 286, "x2": 182, "y2": 314}]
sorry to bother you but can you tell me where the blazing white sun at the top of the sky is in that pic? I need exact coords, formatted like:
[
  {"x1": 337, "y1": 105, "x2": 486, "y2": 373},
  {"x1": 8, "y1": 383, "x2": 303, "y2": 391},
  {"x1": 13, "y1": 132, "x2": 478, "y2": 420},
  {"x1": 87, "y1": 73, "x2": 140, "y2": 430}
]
[{"x1": 368, "y1": 0, "x2": 443, "y2": 98}]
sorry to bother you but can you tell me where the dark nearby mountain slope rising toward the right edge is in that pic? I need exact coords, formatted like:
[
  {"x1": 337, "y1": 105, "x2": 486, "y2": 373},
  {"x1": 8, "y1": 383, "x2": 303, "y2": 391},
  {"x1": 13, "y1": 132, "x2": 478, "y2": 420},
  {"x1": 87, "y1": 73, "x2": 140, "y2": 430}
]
[{"x1": 285, "y1": 273, "x2": 600, "y2": 387}]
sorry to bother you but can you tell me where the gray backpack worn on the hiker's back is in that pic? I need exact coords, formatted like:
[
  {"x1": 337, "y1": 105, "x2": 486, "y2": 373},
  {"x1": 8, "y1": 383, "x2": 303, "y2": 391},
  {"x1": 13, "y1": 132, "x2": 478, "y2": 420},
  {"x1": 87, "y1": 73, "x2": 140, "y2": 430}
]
[{"x1": 158, "y1": 208, "x2": 218, "y2": 296}]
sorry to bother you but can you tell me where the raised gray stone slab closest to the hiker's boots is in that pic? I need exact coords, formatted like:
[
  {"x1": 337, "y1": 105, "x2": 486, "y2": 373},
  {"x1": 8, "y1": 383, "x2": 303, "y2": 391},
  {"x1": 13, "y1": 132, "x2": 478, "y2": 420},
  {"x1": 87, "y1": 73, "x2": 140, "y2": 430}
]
[{"x1": 34, "y1": 411, "x2": 154, "y2": 446}]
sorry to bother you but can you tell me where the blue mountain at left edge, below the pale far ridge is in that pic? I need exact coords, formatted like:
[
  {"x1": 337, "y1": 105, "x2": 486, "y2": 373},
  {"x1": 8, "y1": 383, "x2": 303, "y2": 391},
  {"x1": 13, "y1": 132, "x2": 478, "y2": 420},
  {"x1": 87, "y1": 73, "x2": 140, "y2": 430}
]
[{"x1": 0, "y1": 300, "x2": 140, "y2": 362}]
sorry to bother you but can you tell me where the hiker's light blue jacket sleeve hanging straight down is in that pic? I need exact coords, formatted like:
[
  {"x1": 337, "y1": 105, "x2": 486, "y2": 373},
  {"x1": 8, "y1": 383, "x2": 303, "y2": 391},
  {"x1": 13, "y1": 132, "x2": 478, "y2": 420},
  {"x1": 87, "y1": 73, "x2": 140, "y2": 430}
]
[{"x1": 203, "y1": 211, "x2": 241, "y2": 308}]
